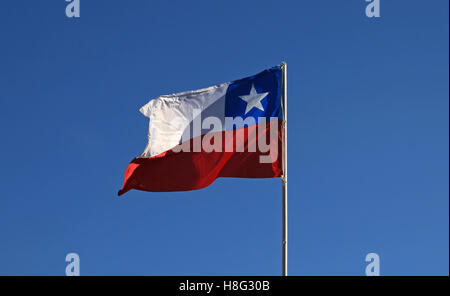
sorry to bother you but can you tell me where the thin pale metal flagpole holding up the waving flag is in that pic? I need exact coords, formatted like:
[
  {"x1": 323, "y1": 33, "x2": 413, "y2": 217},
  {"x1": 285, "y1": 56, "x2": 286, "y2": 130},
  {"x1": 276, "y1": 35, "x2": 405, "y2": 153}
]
[{"x1": 281, "y1": 62, "x2": 288, "y2": 276}]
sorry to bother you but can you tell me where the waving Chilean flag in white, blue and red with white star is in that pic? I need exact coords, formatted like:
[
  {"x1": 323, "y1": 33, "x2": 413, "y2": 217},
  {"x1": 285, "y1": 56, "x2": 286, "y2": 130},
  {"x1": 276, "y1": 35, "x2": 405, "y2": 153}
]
[{"x1": 118, "y1": 66, "x2": 282, "y2": 195}]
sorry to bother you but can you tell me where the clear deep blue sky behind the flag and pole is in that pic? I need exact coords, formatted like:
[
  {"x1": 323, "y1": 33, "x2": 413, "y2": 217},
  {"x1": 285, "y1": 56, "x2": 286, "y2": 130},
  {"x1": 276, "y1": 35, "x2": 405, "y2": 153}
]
[{"x1": 0, "y1": 0, "x2": 449, "y2": 275}]
